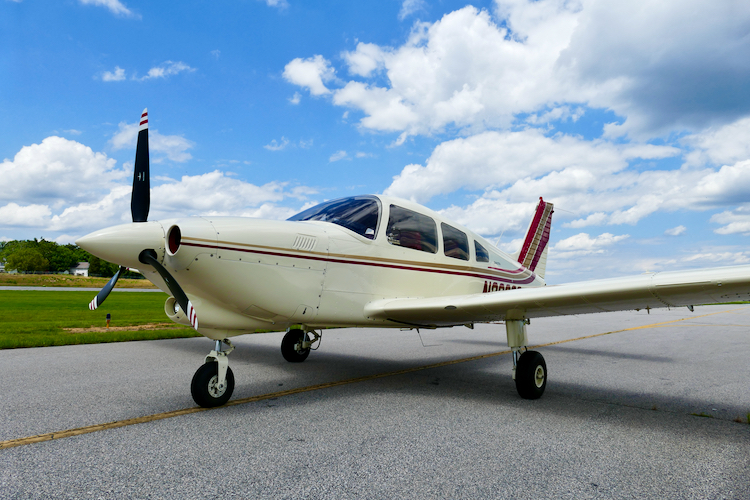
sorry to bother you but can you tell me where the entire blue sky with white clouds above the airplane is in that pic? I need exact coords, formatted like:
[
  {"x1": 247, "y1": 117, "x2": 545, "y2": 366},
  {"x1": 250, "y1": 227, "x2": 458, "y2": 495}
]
[{"x1": 0, "y1": 0, "x2": 750, "y2": 283}]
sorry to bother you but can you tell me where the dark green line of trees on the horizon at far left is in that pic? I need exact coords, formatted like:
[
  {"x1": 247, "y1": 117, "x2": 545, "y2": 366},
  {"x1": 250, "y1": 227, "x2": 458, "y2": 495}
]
[{"x1": 0, "y1": 238, "x2": 141, "y2": 278}]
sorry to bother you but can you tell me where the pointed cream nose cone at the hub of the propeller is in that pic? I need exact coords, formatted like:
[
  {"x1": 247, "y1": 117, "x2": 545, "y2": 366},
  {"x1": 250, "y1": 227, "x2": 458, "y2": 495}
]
[{"x1": 76, "y1": 222, "x2": 164, "y2": 268}]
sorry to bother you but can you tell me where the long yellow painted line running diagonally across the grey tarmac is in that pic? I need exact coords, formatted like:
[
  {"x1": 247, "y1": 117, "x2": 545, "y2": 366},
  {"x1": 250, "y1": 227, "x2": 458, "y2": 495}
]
[{"x1": 0, "y1": 311, "x2": 732, "y2": 450}]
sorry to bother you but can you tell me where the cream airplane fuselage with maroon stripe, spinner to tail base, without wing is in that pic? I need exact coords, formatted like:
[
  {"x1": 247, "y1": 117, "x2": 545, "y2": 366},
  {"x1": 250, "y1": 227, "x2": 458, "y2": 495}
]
[{"x1": 78, "y1": 196, "x2": 544, "y2": 338}]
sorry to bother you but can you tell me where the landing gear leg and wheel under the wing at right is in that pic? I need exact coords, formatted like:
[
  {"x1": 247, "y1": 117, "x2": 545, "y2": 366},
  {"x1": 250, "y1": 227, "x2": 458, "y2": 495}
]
[{"x1": 505, "y1": 319, "x2": 547, "y2": 399}]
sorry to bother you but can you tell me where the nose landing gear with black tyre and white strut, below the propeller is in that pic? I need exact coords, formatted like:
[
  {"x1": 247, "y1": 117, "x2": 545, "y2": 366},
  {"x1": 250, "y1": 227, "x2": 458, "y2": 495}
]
[{"x1": 190, "y1": 339, "x2": 234, "y2": 408}]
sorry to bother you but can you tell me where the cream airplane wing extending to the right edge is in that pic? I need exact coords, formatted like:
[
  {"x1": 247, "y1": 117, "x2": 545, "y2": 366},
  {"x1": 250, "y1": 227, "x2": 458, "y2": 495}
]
[{"x1": 365, "y1": 266, "x2": 750, "y2": 328}]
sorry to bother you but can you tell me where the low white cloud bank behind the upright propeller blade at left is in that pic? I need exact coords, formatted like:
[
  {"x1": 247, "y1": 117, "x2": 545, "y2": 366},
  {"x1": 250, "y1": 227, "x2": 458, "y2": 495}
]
[{"x1": 0, "y1": 137, "x2": 317, "y2": 237}]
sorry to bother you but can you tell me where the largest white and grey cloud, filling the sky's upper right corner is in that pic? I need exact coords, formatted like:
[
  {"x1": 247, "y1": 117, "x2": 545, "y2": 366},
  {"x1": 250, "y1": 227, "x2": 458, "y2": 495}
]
[{"x1": 287, "y1": 0, "x2": 750, "y2": 138}]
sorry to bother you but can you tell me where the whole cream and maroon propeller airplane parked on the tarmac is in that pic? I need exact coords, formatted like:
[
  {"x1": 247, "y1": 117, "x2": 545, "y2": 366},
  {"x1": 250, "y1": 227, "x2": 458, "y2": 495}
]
[{"x1": 76, "y1": 110, "x2": 750, "y2": 407}]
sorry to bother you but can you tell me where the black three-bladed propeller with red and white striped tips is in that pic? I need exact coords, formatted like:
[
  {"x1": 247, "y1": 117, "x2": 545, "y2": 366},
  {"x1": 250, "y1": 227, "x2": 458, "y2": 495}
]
[{"x1": 89, "y1": 108, "x2": 198, "y2": 330}]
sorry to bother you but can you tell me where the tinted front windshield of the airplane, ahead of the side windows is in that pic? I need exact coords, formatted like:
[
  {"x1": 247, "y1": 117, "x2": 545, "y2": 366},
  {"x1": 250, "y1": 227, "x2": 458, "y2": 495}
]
[{"x1": 288, "y1": 196, "x2": 380, "y2": 240}]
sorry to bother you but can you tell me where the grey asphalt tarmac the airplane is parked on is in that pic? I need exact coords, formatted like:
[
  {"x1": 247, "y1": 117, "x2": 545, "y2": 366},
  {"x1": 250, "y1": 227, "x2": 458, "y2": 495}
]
[{"x1": 0, "y1": 305, "x2": 750, "y2": 499}]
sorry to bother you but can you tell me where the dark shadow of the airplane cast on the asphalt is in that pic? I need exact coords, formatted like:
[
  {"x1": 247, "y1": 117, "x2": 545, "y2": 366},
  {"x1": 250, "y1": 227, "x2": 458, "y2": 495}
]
[{"x1": 150, "y1": 342, "x2": 750, "y2": 428}]
